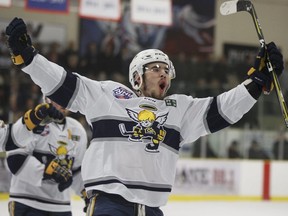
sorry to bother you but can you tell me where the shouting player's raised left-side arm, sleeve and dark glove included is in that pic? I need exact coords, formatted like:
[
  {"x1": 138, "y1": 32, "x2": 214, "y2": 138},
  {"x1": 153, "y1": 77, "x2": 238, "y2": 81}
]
[{"x1": 6, "y1": 18, "x2": 107, "y2": 114}]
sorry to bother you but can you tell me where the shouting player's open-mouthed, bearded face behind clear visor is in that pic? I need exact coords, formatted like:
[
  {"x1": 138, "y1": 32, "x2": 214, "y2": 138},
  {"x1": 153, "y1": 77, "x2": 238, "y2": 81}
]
[{"x1": 141, "y1": 62, "x2": 170, "y2": 100}]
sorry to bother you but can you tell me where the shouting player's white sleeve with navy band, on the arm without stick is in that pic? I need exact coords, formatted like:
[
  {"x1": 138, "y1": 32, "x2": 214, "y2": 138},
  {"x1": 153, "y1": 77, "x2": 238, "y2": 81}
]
[{"x1": 22, "y1": 54, "x2": 102, "y2": 114}]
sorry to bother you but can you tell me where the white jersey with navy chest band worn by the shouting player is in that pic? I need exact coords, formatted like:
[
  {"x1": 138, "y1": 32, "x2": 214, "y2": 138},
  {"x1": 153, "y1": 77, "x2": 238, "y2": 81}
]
[{"x1": 23, "y1": 54, "x2": 256, "y2": 207}]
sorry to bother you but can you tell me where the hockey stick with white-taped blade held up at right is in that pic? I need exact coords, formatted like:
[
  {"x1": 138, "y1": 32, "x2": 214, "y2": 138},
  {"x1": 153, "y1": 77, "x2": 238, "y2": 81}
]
[{"x1": 220, "y1": 0, "x2": 288, "y2": 128}]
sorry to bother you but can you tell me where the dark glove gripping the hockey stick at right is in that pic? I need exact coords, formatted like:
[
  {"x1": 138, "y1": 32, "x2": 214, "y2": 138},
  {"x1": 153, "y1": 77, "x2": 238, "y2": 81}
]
[{"x1": 247, "y1": 42, "x2": 284, "y2": 94}]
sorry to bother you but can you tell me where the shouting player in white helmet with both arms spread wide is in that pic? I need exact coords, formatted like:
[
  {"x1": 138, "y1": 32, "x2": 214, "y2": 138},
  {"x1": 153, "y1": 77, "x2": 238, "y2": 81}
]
[{"x1": 6, "y1": 18, "x2": 283, "y2": 216}]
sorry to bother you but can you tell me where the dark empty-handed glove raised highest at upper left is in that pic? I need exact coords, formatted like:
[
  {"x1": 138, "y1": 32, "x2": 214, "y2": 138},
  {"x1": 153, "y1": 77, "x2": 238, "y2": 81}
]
[{"x1": 6, "y1": 17, "x2": 38, "y2": 66}]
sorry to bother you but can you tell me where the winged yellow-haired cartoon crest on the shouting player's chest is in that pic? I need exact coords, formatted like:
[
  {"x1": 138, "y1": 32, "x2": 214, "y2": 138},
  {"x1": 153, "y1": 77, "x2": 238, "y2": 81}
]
[{"x1": 119, "y1": 108, "x2": 168, "y2": 153}]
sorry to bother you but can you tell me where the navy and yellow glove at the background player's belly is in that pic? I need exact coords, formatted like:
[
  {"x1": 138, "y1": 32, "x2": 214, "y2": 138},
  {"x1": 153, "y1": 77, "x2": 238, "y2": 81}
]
[{"x1": 44, "y1": 159, "x2": 73, "y2": 192}]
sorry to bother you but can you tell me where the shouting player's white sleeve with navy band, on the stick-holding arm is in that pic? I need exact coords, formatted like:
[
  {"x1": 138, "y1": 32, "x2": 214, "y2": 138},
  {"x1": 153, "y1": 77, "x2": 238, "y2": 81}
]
[{"x1": 181, "y1": 84, "x2": 256, "y2": 145}]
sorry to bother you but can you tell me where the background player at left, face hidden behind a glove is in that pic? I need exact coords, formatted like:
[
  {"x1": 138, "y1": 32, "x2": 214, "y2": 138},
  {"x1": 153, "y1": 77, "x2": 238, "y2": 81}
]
[{"x1": 3, "y1": 102, "x2": 87, "y2": 216}]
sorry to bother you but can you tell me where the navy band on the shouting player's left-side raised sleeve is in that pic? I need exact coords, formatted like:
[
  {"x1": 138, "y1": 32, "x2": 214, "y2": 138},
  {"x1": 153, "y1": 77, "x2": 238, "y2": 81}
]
[{"x1": 47, "y1": 72, "x2": 77, "y2": 107}]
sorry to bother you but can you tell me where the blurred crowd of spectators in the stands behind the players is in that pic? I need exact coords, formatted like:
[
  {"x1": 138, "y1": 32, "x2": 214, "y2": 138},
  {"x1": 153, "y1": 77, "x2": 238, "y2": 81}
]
[{"x1": 0, "y1": 31, "x2": 288, "y2": 160}]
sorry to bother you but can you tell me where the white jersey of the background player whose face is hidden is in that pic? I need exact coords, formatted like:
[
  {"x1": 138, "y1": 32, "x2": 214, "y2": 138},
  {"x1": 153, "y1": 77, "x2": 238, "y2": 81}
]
[{"x1": 5, "y1": 117, "x2": 87, "y2": 212}]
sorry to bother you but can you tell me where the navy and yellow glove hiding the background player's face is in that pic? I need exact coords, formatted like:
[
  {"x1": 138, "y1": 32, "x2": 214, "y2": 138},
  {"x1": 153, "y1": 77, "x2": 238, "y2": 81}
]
[{"x1": 22, "y1": 103, "x2": 64, "y2": 130}]
